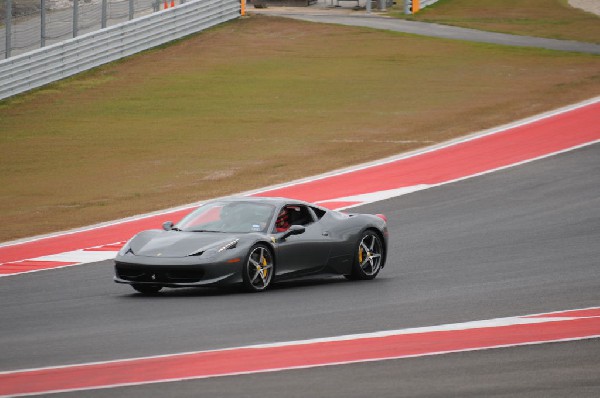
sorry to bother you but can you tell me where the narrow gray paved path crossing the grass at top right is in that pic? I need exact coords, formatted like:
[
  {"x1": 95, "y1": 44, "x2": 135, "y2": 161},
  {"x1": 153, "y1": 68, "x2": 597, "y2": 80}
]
[{"x1": 250, "y1": 8, "x2": 600, "y2": 54}]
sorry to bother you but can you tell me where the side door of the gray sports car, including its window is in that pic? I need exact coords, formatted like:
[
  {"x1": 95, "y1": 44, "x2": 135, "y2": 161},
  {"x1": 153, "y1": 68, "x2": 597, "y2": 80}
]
[{"x1": 277, "y1": 204, "x2": 331, "y2": 278}]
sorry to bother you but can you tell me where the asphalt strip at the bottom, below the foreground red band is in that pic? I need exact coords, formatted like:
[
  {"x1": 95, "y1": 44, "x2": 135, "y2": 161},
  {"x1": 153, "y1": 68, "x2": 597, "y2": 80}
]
[{"x1": 56, "y1": 340, "x2": 600, "y2": 398}]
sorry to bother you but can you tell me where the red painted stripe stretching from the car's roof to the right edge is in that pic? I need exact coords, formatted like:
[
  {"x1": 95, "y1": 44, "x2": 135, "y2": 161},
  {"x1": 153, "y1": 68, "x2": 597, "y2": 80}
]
[{"x1": 260, "y1": 103, "x2": 600, "y2": 202}]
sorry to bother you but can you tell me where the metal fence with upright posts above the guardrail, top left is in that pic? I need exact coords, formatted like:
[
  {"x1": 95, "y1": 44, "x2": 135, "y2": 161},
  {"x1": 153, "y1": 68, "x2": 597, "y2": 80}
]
[{"x1": 0, "y1": 0, "x2": 190, "y2": 59}]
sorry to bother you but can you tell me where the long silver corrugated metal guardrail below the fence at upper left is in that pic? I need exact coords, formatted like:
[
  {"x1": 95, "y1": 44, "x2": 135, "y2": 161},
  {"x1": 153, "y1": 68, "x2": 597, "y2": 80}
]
[{"x1": 0, "y1": 0, "x2": 240, "y2": 100}]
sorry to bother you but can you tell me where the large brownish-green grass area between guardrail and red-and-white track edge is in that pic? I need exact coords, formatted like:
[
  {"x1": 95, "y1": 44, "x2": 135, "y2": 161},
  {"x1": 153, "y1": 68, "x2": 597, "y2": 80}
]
[{"x1": 0, "y1": 16, "x2": 600, "y2": 241}]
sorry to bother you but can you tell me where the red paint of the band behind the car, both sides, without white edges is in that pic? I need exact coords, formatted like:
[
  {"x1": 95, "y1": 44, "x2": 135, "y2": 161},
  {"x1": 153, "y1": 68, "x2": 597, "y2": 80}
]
[{"x1": 0, "y1": 102, "x2": 600, "y2": 270}]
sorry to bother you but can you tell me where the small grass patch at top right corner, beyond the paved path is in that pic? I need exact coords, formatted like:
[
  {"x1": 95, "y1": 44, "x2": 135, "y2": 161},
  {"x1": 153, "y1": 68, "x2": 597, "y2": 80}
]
[{"x1": 390, "y1": 0, "x2": 600, "y2": 43}]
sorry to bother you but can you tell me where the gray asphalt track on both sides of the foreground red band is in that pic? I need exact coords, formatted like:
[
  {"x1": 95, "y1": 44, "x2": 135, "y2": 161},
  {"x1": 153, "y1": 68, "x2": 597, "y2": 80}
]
[{"x1": 0, "y1": 144, "x2": 600, "y2": 397}]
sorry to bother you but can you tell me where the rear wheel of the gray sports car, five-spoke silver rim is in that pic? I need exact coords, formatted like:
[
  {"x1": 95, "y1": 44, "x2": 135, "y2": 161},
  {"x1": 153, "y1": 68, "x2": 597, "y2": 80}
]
[{"x1": 345, "y1": 230, "x2": 385, "y2": 280}]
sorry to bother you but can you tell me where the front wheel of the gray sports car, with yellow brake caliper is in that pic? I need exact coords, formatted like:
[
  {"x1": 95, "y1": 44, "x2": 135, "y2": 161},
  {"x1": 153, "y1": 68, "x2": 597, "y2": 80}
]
[{"x1": 242, "y1": 243, "x2": 275, "y2": 292}]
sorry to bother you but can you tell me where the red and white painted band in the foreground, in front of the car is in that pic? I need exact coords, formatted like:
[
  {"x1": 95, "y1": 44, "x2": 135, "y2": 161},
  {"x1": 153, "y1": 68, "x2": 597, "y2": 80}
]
[{"x1": 0, "y1": 307, "x2": 600, "y2": 397}]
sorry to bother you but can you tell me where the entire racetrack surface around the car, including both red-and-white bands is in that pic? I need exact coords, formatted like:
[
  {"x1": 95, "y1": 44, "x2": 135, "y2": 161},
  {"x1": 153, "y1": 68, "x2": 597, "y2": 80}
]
[{"x1": 0, "y1": 98, "x2": 600, "y2": 397}]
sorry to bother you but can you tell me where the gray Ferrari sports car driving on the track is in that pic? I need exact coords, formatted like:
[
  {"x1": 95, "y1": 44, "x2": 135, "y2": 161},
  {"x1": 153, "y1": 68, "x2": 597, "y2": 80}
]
[{"x1": 114, "y1": 197, "x2": 388, "y2": 294}]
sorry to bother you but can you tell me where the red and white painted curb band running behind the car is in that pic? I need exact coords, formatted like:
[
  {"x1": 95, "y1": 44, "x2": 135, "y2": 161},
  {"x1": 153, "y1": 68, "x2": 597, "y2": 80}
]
[{"x1": 0, "y1": 97, "x2": 600, "y2": 277}]
